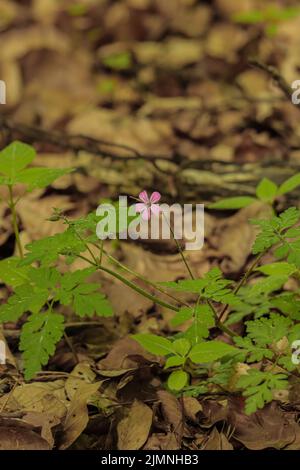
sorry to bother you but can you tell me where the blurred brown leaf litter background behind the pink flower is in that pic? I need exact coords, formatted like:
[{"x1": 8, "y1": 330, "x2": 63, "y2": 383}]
[{"x1": 0, "y1": 0, "x2": 300, "y2": 266}]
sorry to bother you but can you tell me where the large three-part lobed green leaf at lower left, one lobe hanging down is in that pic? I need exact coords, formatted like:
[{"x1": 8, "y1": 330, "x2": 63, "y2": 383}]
[{"x1": 0, "y1": 259, "x2": 112, "y2": 379}]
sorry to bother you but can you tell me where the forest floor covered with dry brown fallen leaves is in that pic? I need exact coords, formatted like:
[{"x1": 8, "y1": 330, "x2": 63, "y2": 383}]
[{"x1": 0, "y1": 0, "x2": 300, "y2": 450}]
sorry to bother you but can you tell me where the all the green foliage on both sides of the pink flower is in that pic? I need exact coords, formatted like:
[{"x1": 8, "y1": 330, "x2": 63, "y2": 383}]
[{"x1": 0, "y1": 142, "x2": 300, "y2": 413}]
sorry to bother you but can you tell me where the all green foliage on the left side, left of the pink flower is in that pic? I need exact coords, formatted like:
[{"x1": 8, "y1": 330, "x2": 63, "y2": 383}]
[{"x1": 0, "y1": 141, "x2": 112, "y2": 380}]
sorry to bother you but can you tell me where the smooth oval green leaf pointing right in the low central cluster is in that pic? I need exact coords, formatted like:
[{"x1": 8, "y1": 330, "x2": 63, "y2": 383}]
[{"x1": 189, "y1": 340, "x2": 237, "y2": 364}]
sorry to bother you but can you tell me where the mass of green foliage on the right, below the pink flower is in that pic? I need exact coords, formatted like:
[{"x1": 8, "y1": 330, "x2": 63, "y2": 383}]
[{"x1": 135, "y1": 183, "x2": 300, "y2": 414}]
